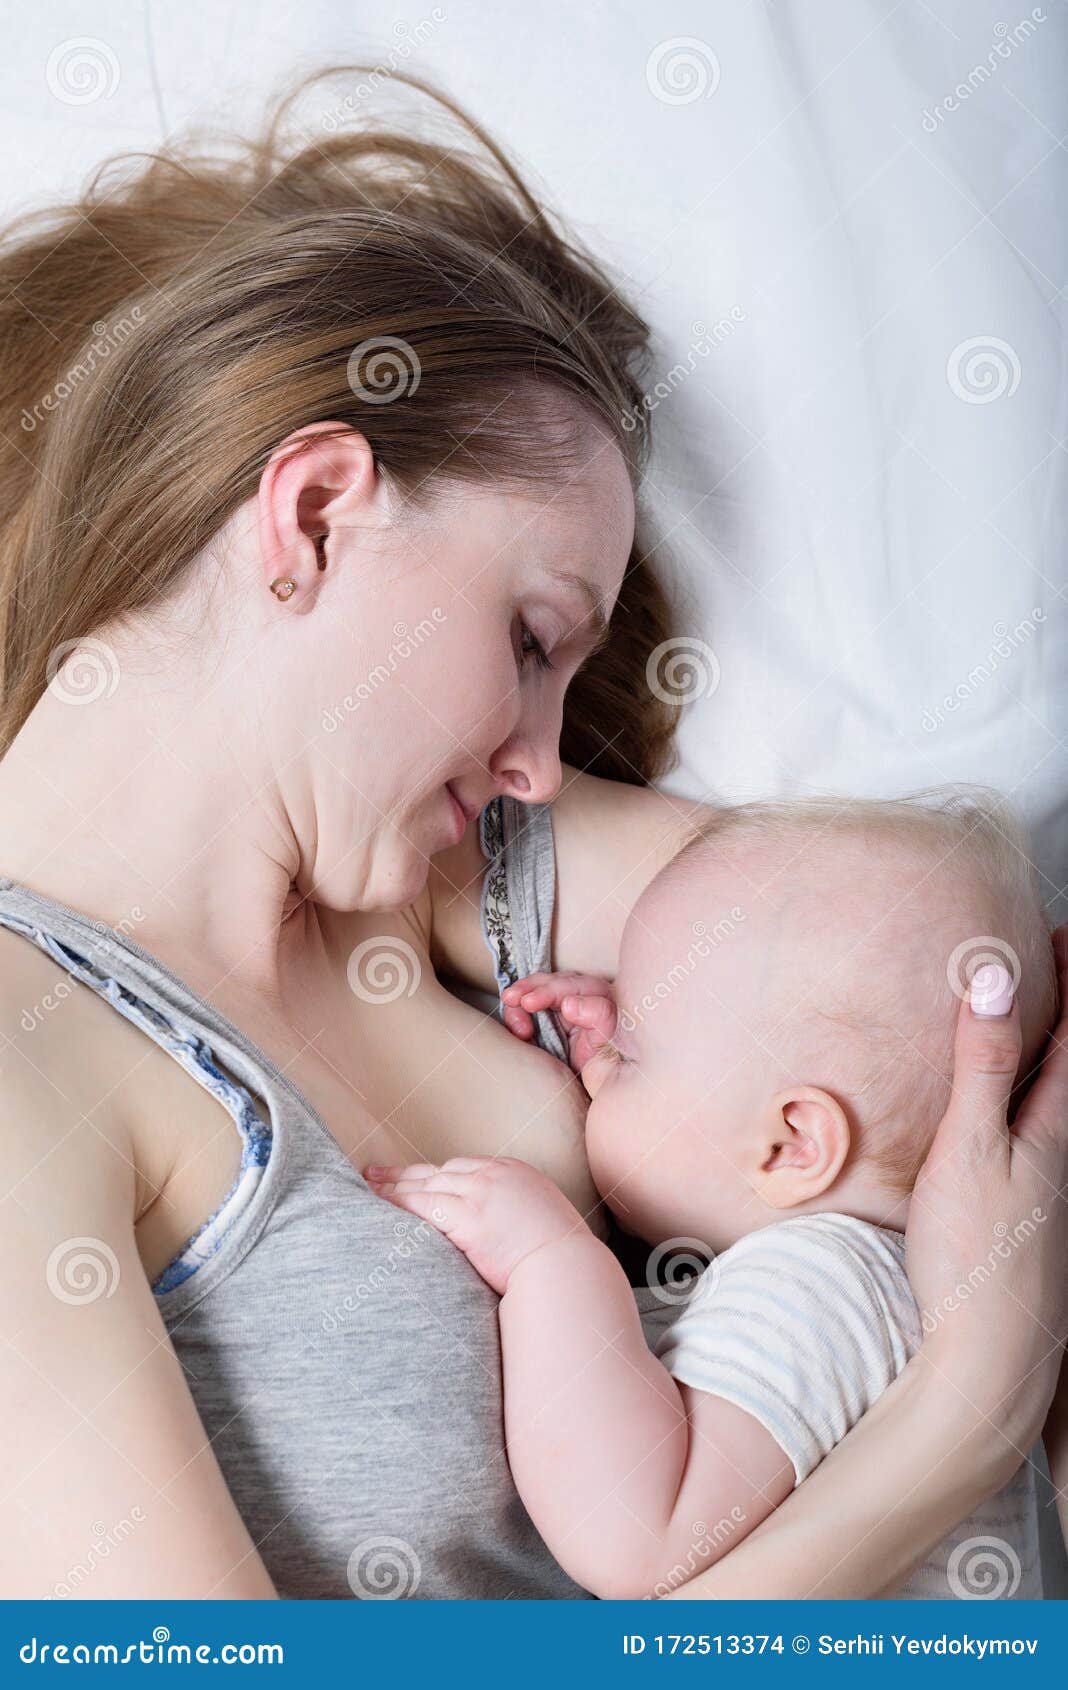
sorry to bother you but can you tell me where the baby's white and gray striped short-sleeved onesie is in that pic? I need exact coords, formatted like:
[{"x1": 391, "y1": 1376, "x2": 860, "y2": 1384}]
[{"x1": 654, "y1": 1215, "x2": 1043, "y2": 1600}]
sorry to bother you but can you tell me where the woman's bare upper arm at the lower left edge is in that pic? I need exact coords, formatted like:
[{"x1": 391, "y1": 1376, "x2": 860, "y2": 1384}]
[{"x1": 0, "y1": 1063, "x2": 275, "y2": 1599}]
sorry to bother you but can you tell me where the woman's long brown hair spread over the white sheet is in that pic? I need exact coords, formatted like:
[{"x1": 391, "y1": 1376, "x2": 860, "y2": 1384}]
[{"x1": 0, "y1": 66, "x2": 674, "y2": 781}]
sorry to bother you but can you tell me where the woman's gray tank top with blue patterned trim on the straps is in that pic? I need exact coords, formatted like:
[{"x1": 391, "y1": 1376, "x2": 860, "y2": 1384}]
[{"x1": 0, "y1": 799, "x2": 585, "y2": 1599}]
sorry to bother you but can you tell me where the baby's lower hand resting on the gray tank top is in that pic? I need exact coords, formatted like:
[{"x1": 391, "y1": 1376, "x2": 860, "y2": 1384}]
[{"x1": 363, "y1": 1156, "x2": 586, "y2": 1296}]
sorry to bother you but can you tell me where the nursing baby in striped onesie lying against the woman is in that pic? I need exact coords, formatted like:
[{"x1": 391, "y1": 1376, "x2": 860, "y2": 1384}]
[{"x1": 367, "y1": 794, "x2": 1056, "y2": 1599}]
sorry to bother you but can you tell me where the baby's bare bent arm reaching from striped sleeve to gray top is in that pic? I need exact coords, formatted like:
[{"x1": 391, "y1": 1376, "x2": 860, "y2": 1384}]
[{"x1": 367, "y1": 1158, "x2": 794, "y2": 1597}]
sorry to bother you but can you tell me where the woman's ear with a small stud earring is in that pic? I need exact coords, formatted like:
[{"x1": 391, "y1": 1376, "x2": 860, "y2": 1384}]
[{"x1": 259, "y1": 423, "x2": 379, "y2": 612}]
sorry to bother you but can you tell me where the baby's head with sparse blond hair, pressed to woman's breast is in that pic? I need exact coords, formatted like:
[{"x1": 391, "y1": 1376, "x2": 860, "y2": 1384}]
[{"x1": 583, "y1": 793, "x2": 1056, "y2": 1251}]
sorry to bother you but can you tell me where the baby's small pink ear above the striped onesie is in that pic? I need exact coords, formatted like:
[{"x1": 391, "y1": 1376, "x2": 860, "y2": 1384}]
[{"x1": 754, "y1": 1085, "x2": 850, "y2": 1208}]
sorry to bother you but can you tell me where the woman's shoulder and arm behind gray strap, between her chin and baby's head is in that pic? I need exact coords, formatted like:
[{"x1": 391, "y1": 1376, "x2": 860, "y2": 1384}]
[{"x1": 429, "y1": 769, "x2": 708, "y2": 990}]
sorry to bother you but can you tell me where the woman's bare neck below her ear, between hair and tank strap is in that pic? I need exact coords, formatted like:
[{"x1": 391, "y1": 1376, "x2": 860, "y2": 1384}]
[{"x1": 0, "y1": 621, "x2": 309, "y2": 1000}]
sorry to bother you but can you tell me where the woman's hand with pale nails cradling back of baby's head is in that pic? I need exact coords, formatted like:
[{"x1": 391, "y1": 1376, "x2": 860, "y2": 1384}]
[{"x1": 907, "y1": 928, "x2": 1068, "y2": 1477}]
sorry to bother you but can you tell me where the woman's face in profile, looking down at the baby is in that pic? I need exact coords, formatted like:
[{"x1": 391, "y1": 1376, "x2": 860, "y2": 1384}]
[{"x1": 292, "y1": 433, "x2": 634, "y2": 909}]
